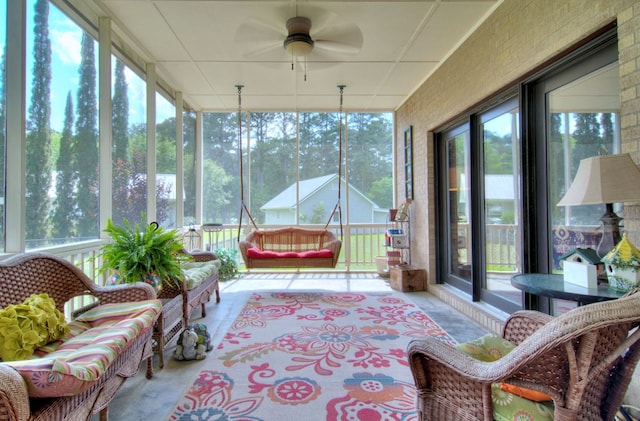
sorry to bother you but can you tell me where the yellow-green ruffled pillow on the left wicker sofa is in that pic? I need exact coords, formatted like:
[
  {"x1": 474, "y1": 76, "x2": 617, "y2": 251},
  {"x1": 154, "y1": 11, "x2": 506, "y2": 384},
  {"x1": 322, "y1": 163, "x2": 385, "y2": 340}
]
[{"x1": 0, "y1": 294, "x2": 69, "y2": 361}]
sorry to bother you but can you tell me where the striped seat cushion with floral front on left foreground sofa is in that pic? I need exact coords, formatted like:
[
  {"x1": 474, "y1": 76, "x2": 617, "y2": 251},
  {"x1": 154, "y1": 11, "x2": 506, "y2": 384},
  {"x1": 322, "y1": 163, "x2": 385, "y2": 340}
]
[{"x1": 6, "y1": 300, "x2": 162, "y2": 398}]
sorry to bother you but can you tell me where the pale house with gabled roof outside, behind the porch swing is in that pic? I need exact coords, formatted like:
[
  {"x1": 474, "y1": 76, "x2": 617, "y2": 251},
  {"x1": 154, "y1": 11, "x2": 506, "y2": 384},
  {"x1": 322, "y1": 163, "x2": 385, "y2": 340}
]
[{"x1": 260, "y1": 174, "x2": 388, "y2": 225}]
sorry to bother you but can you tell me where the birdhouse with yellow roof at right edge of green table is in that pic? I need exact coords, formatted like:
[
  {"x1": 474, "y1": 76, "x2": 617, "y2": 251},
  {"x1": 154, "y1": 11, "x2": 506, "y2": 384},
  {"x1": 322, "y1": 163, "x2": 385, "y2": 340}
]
[{"x1": 602, "y1": 232, "x2": 640, "y2": 291}]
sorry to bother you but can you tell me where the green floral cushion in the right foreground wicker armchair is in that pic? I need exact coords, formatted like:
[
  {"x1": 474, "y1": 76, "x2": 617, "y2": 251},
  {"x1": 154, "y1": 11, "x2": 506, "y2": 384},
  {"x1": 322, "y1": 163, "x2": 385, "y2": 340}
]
[{"x1": 456, "y1": 334, "x2": 553, "y2": 421}]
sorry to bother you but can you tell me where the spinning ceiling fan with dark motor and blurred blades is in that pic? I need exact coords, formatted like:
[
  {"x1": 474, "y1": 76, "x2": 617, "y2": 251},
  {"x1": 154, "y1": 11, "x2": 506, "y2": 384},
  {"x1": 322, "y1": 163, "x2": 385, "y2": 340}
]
[{"x1": 236, "y1": 8, "x2": 363, "y2": 71}]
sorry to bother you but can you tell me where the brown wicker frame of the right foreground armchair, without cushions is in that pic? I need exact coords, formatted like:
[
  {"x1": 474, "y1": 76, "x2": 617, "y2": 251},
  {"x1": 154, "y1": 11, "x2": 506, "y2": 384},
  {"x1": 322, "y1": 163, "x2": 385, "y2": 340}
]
[{"x1": 408, "y1": 290, "x2": 640, "y2": 421}]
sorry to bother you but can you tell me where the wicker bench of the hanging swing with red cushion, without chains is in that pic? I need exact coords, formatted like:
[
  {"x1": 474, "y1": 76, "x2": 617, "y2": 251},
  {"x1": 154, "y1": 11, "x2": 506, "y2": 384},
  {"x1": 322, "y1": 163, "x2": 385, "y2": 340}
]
[{"x1": 240, "y1": 227, "x2": 341, "y2": 268}]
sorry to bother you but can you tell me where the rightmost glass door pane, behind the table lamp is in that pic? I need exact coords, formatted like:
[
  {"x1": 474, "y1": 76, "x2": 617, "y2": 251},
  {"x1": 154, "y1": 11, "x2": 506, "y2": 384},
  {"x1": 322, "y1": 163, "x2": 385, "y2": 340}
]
[{"x1": 545, "y1": 62, "x2": 624, "y2": 314}]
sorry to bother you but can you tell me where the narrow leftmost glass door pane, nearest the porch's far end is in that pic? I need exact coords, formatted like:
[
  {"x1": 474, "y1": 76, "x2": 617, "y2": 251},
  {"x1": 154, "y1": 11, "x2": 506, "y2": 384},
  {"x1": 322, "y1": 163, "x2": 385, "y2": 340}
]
[{"x1": 445, "y1": 126, "x2": 473, "y2": 292}]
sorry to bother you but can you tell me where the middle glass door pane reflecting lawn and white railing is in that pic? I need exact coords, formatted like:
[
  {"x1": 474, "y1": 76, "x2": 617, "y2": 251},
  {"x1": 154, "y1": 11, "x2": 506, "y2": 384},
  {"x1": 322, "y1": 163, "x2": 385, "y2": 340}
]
[{"x1": 480, "y1": 101, "x2": 522, "y2": 306}]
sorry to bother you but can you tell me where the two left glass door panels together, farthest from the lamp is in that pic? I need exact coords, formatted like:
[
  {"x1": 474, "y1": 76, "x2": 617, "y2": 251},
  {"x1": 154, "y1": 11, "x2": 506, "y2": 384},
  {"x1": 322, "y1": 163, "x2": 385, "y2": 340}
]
[{"x1": 437, "y1": 92, "x2": 523, "y2": 311}]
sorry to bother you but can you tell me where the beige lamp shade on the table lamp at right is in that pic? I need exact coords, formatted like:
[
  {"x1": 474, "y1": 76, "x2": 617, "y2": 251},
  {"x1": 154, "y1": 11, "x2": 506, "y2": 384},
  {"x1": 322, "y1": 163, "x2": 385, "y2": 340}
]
[{"x1": 558, "y1": 154, "x2": 640, "y2": 206}]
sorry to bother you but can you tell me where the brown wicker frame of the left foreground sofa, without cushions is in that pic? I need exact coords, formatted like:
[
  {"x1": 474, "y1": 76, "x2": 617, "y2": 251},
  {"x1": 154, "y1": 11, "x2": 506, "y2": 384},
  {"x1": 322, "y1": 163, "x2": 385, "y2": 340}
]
[{"x1": 0, "y1": 253, "x2": 160, "y2": 420}]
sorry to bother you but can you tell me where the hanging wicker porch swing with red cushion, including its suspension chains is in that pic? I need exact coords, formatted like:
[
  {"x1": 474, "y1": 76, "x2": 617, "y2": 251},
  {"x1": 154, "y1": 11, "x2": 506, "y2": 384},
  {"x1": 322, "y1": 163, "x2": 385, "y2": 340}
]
[{"x1": 236, "y1": 85, "x2": 345, "y2": 269}]
